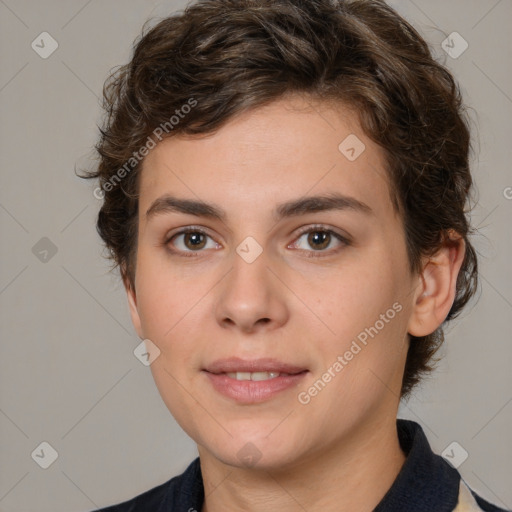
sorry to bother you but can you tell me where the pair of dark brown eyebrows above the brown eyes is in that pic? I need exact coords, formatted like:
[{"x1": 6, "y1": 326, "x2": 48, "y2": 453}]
[{"x1": 146, "y1": 193, "x2": 374, "y2": 222}]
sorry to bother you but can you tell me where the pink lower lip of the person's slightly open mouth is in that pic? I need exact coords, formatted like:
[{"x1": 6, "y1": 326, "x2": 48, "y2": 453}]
[{"x1": 204, "y1": 371, "x2": 308, "y2": 404}]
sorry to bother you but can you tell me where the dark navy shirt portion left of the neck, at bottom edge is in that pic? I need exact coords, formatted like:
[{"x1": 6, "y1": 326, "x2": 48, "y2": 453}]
[{"x1": 91, "y1": 457, "x2": 204, "y2": 512}]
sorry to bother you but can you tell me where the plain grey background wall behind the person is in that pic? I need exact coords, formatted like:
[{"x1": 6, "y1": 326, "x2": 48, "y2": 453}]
[{"x1": 0, "y1": 0, "x2": 512, "y2": 512}]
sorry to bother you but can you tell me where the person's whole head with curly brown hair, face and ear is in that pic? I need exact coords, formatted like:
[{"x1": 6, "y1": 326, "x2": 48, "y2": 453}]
[{"x1": 82, "y1": 0, "x2": 477, "y2": 470}]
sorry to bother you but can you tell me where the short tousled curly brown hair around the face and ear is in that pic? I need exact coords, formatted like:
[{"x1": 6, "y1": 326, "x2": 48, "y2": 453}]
[{"x1": 82, "y1": 0, "x2": 478, "y2": 398}]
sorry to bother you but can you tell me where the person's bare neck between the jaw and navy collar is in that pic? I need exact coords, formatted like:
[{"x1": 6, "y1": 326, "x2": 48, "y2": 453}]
[{"x1": 199, "y1": 416, "x2": 405, "y2": 512}]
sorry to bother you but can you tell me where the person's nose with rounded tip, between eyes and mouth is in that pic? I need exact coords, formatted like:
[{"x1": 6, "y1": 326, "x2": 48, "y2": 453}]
[{"x1": 215, "y1": 245, "x2": 289, "y2": 333}]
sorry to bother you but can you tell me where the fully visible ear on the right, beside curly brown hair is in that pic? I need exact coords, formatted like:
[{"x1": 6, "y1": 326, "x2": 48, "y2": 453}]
[{"x1": 408, "y1": 231, "x2": 466, "y2": 337}]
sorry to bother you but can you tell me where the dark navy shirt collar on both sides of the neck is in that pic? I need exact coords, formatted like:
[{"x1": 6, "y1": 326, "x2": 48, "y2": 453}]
[{"x1": 158, "y1": 419, "x2": 460, "y2": 512}]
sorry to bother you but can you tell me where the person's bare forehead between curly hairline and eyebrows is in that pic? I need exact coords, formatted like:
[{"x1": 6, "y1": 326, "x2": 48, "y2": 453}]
[{"x1": 140, "y1": 96, "x2": 392, "y2": 224}]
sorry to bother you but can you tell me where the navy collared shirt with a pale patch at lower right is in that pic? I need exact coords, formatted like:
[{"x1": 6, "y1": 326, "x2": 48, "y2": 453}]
[{"x1": 94, "y1": 419, "x2": 510, "y2": 512}]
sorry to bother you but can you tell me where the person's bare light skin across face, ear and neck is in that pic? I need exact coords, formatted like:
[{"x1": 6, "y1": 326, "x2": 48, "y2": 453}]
[{"x1": 125, "y1": 95, "x2": 464, "y2": 512}]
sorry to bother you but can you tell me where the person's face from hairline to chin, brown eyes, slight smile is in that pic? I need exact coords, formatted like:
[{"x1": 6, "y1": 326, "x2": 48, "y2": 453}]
[{"x1": 128, "y1": 96, "x2": 417, "y2": 468}]
